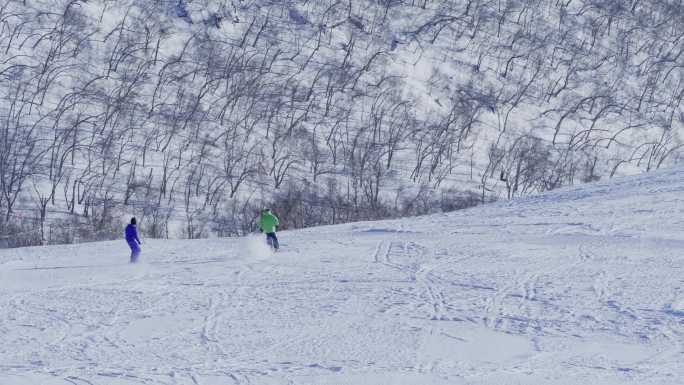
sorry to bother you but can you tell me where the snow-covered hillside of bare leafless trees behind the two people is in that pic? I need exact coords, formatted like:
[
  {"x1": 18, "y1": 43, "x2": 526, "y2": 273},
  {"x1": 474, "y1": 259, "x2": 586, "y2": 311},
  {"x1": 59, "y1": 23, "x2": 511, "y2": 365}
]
[{"x1": 0, "y1": 0, "x2": 684, "y2": 247}]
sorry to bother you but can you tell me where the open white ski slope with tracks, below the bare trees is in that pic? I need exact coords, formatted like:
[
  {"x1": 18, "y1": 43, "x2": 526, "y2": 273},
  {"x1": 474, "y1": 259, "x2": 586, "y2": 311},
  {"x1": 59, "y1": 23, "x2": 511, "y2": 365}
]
[{"x1": 0, "y1": 170, "x2": 684, "y2": 385}]
